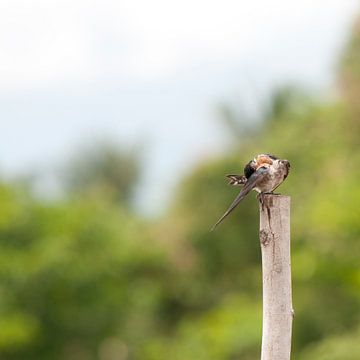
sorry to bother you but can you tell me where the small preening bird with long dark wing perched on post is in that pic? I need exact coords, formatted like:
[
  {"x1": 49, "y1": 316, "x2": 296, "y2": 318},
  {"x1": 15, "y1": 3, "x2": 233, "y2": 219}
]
[{"x1": 211, "y1": 154, "x2": 290, "y2": 231}]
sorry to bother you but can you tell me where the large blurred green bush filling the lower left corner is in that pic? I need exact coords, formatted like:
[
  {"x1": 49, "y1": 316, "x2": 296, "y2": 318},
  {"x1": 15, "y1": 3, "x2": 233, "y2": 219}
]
[{"x1": 0, "y1": 185, "x2": 167, "y2": 360}]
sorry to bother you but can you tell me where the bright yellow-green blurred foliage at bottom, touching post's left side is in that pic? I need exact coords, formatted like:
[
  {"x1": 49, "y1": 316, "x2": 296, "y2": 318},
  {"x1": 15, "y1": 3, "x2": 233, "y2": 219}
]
[{"x1": 144, "y1": 296, "x2": 261, "y2": 360}]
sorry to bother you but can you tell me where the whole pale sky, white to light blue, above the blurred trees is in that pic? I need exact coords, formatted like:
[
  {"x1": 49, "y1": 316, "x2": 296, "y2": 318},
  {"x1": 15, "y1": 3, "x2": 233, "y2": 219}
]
[{"x1": 0, "y1": 0, "x2": 360, "y2": 214}]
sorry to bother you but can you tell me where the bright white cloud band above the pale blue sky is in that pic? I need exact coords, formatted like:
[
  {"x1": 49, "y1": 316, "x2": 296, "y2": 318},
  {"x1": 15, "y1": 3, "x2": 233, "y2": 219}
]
[{"x1": 0, "y1": 0, "x2": 357, "y2": 90}]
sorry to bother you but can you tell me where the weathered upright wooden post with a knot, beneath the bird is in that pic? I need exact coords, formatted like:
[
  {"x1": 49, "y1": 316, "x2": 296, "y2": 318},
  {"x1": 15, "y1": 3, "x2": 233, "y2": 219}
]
[{"x1": 260, "y1": 194, "x2": 294, "y2": 360}]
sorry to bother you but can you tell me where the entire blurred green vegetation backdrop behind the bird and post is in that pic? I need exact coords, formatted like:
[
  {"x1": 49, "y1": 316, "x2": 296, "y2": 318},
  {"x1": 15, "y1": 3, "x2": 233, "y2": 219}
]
[{"x1": 0, "y1": 16, "x2": 360, "y2": 360}]
